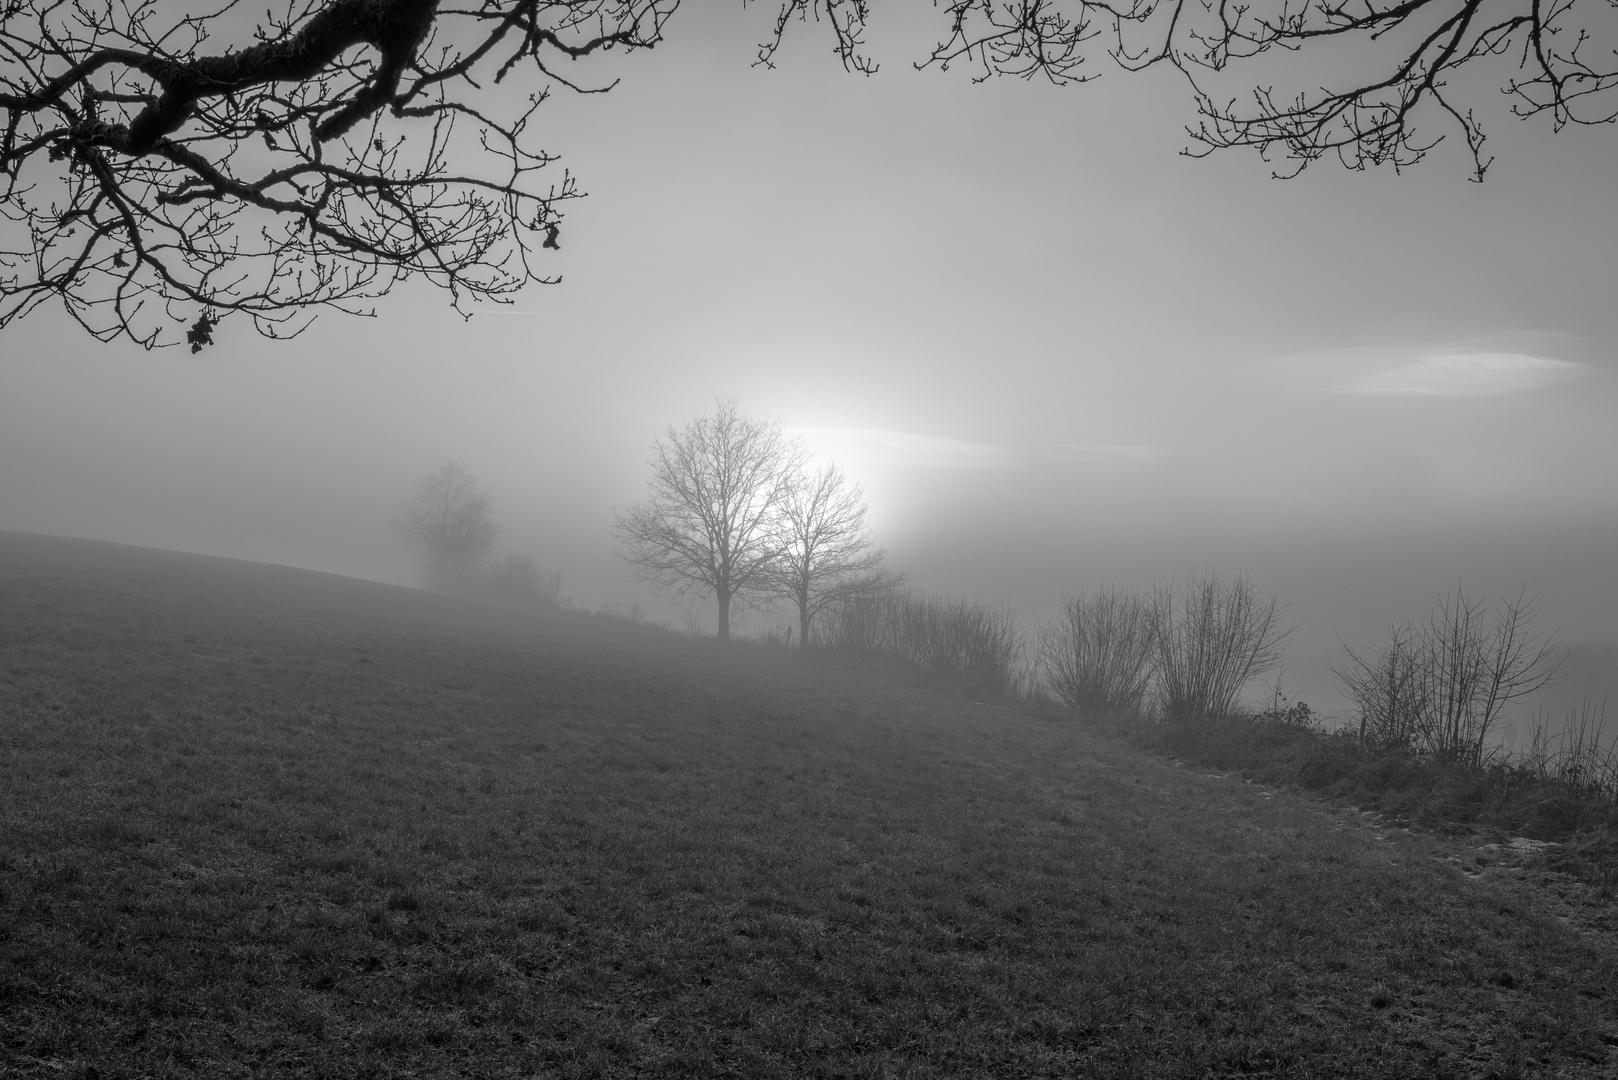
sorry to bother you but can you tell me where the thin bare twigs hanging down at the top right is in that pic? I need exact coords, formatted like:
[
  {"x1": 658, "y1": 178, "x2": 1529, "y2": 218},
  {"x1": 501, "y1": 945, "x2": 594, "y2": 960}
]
[{"x1": 912, "y1": 0, "x2": 1618, "y2": 180}]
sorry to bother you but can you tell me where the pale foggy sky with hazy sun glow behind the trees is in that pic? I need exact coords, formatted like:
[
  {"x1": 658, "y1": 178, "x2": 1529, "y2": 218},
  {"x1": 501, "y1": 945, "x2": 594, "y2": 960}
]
[{"x1": 0, "y1": 8, "x2": 1618, "y2": 718}]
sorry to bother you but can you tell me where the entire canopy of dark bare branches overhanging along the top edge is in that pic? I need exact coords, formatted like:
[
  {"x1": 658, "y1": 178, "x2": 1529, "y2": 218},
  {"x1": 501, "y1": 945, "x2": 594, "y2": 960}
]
[{"x1": 0, "y1": 0, "x2": 1618, "y2": 350}]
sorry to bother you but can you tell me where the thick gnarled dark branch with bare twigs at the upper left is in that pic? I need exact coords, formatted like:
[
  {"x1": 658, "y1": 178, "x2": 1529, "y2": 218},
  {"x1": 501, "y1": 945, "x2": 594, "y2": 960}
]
[{"x1": 0, "y1": 0, "x2": 676, "y2": 348}]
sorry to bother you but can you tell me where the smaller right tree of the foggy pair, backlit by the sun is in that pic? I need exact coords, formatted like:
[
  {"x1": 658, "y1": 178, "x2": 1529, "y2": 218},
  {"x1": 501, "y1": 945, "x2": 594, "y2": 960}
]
[{"x1": 770, "y1": 465, "x2": 904, "y2": 646}]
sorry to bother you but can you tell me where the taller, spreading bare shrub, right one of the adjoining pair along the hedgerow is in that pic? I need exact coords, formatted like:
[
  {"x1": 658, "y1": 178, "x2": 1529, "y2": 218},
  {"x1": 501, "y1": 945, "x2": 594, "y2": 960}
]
[{"x1": 1152, "y1": 570, "x2": 1290, "y2": 721}]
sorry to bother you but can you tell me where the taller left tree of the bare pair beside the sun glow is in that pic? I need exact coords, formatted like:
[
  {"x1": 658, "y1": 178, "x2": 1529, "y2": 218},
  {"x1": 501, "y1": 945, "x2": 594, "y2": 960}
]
[{"x1": 613, "y1": 400, "x2": 803, "y2": 641}]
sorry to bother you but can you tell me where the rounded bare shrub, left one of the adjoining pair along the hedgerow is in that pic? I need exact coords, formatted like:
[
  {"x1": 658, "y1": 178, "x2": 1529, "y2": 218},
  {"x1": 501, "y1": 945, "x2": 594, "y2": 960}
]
[{"x1": 1039, "y1": 586, "x2": 1157, "y2": 719}]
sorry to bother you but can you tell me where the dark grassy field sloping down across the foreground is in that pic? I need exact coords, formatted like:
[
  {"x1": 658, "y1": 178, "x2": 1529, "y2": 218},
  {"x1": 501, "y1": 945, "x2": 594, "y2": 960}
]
[{"x1": 0, "y1": 533, "x2": 1618, "y2": 1080}]
